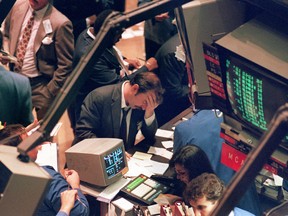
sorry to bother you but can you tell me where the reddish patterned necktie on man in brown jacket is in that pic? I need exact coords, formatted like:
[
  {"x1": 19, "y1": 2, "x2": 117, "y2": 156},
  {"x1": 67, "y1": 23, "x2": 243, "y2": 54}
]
[{"x1": 14, "y1": 12, "x2": 35, "y2": 72}]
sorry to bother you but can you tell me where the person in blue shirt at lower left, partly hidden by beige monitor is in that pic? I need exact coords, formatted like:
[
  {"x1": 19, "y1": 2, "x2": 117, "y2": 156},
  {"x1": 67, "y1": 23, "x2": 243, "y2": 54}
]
[{"x1": 0, "y1": 124, "x2": 89, "y2": 216}]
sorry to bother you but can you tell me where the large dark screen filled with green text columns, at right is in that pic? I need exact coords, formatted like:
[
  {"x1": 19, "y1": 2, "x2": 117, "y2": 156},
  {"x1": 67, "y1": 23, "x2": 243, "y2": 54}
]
[{"x1": 219, "y1": 49, "x2": 288, "y2": 133}]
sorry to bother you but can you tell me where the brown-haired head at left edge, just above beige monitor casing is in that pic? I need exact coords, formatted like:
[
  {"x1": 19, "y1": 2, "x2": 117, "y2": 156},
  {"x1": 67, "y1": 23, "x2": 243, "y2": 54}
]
[{"x1": 0, "y1": 124, "x2": 41, "y2": 161}]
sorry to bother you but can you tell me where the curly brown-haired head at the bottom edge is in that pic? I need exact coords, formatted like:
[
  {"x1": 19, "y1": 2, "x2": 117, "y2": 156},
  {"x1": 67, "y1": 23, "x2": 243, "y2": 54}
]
[{"x1": 184, "y1": 173, "x2": 225, "y2": 216}]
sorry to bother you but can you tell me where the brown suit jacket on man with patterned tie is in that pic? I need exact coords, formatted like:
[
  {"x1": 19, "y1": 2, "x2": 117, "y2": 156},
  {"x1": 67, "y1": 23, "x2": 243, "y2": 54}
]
[{"x1": 3, "y1": 0, "x2": 74, "y2": 96}]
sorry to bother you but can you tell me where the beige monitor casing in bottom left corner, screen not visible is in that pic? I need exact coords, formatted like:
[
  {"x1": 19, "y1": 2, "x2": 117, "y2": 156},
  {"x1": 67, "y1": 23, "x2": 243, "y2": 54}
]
[{"x1": 0, "y1": 145, "x2": 51, "y2": 215}]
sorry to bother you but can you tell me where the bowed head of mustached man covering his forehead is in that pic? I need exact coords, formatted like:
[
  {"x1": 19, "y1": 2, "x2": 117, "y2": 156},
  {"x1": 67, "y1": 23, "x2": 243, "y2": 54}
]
[{"x1": 124, "y1": 72, "x2": 164, "y2": 110}]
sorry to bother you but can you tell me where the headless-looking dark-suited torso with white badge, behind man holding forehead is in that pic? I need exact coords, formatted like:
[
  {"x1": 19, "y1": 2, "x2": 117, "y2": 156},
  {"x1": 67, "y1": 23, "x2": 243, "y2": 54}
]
[{"x1": 155, "y1": 34, "x2": 191, "y2": 126}]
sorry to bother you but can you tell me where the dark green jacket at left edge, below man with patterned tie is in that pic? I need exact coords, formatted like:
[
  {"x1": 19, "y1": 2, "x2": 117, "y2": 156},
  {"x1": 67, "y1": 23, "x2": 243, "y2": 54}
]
[{"x1": 0, "y1": 66, "x2": 34, "y2": 126}]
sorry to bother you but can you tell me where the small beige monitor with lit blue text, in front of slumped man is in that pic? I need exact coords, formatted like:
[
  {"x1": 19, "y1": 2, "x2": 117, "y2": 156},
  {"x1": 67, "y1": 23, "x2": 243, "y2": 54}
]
[{"x1": 65, "y1": 138, "x2": 128, "y2": 187}]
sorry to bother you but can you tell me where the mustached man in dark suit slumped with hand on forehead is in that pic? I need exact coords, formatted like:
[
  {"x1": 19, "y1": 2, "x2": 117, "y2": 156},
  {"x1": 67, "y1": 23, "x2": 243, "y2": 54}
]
[{"x1": 73, "y1": 72, "x2": 163, "y2": 150}]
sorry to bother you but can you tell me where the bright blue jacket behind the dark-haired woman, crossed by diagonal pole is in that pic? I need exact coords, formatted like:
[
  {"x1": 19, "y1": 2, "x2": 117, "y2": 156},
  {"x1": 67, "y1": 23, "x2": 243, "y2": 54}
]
[{"x1": 173, "y1": 110, "x2": 261, "y2": 216}]
